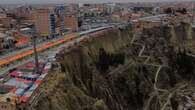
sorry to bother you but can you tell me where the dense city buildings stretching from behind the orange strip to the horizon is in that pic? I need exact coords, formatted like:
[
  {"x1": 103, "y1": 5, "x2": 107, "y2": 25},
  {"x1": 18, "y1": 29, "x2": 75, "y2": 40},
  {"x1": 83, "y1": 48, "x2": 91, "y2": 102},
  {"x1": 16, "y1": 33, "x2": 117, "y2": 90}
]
[{"x1": 0, "y1": 2, "x2": 192, "y2": 53}]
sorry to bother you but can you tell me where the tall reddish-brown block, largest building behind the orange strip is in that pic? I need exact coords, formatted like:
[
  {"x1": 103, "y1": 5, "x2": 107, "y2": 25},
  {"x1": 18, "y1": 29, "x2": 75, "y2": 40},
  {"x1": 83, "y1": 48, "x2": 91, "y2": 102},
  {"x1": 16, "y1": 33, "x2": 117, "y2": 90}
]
[{"x1": 34, "y1": 9, "x2": 56, "y2": 36}]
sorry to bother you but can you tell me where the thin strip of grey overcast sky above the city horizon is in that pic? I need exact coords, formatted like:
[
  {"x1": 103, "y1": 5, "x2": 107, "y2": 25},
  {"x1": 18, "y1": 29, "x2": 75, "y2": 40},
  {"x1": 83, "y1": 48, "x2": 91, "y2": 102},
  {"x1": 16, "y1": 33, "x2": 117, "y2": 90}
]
[{"x1": 0, "y1": 0, "x2": 192, "y2": 4}]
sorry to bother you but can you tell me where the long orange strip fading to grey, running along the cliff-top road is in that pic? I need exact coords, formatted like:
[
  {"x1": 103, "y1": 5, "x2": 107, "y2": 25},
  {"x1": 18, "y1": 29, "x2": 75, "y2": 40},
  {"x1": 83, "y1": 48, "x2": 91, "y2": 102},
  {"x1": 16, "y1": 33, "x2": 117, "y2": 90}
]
[{"x1": 0, "y1": 26, "x2": 113, "y2": 68}]
